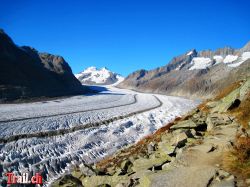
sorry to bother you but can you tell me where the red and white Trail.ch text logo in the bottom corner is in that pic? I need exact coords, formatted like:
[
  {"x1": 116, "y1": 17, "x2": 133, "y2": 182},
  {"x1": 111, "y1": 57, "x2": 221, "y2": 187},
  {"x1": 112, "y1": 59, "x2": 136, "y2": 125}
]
[{"x1": 5, "y1": 172, "x2": 43, "y2": 187}]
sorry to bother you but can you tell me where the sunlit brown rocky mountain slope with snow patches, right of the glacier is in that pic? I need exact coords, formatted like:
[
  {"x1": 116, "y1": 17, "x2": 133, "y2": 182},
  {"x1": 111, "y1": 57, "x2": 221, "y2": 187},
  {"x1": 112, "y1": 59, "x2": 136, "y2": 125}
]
[{"x1": 118, "y1": 42, "x2": 250, "y2": 98}]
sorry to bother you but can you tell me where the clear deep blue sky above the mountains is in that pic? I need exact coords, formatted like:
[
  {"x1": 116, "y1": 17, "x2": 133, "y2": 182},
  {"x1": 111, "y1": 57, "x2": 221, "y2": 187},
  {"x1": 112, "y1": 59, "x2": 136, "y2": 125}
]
[{"x1": 0, "y1": 0, "x2": 250, "y2": 76}]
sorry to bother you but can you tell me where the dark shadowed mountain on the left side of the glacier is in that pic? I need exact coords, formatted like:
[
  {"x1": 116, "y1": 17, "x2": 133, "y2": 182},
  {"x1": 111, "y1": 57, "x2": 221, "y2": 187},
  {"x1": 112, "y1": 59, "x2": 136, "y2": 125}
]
[{"x1": 0, "y1": 30, "x2": 84, "y2": 101}]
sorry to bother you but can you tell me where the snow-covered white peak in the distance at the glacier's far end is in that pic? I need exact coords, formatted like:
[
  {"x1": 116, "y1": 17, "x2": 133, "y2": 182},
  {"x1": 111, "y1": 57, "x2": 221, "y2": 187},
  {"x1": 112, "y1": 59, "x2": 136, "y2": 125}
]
[{"x1": 75, "y1": 67, "x2": 124, "y2": 85}]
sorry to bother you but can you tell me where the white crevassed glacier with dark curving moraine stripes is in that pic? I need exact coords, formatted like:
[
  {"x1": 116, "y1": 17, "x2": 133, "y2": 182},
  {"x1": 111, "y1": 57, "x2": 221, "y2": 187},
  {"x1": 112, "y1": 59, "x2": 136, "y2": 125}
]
[{"x1": 0, "y1": 88, "x2": 197, "y2": 185}]
